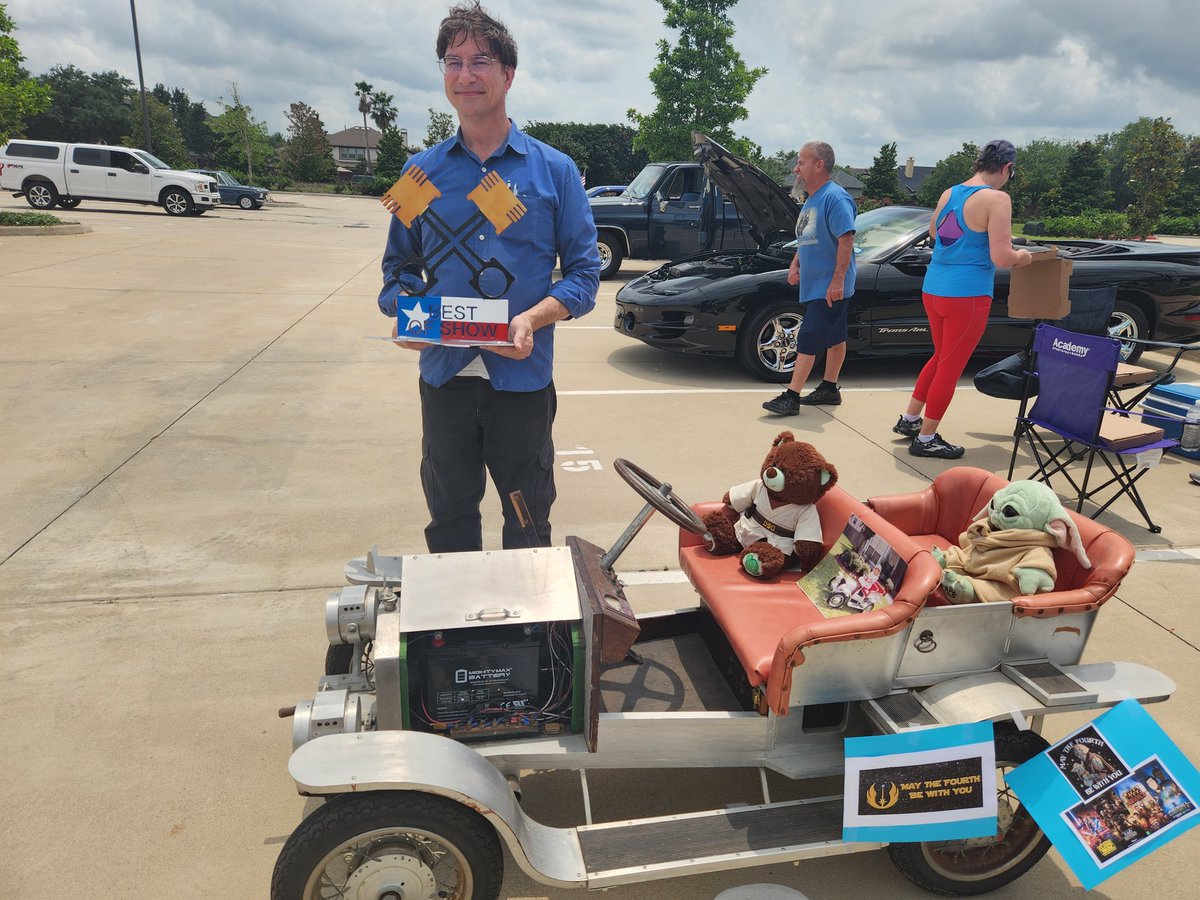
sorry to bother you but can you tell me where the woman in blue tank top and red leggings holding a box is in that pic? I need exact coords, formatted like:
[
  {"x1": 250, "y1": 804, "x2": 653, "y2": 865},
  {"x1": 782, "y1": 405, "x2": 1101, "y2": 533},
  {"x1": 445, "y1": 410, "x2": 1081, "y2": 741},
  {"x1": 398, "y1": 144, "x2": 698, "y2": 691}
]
[{"x1": 892, "y1": 140, "x2": 1032, "y2": 460}]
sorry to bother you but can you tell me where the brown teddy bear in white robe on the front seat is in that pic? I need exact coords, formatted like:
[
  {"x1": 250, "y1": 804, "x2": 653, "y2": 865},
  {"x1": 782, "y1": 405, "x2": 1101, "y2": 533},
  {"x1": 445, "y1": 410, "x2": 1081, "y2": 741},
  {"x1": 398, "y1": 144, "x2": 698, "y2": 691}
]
[{"x1": 703, "y1": 431, "x2": 838, "y2": 578}]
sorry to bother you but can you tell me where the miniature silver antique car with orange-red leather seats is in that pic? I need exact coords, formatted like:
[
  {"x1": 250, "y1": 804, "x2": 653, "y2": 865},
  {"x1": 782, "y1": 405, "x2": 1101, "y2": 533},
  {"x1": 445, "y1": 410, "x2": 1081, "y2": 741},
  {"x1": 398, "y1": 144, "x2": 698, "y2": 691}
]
[{"x1": 271, "y1": 468, "x2": 1175, "y2": 900}]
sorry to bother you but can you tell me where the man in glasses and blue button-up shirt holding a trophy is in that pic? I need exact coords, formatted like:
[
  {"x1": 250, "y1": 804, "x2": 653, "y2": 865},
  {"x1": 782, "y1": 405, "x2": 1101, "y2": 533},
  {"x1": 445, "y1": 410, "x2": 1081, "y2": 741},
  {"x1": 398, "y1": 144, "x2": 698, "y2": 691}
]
[{"x1": 379, "y1": 2, "x2": 600, "y2": 553}]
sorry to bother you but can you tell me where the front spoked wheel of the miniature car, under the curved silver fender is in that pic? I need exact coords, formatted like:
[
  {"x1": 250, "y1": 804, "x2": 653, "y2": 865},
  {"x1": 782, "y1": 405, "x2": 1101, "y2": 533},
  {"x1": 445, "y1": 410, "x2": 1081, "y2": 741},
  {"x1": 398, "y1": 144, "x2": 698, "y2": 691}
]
[{"x1": 271, "y1": 791, "x2": 504, "y2": 900}]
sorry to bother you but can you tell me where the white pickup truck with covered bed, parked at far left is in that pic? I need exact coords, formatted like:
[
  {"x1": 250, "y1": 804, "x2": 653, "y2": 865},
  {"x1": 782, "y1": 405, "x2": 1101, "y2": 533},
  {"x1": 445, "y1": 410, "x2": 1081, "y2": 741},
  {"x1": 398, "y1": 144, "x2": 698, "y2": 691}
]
[{"x1": 0, "y1": 140, "x2": 221, "y2": 216}]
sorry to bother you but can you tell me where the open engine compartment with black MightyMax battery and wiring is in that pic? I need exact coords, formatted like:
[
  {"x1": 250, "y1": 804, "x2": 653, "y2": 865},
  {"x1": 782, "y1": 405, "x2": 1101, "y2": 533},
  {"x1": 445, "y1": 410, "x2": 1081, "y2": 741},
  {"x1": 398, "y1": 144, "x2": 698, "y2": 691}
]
[{"x1": 406, "y1": 624, "x2": 572, "y2": 740}]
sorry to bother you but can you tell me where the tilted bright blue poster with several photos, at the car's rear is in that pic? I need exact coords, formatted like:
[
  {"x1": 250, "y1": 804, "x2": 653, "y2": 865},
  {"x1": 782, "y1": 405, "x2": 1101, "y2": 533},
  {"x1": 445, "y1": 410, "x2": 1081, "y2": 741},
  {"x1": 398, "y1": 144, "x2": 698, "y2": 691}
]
[{"x1": 1006, "y1": 700, "x2": 1200, "y2": 889}]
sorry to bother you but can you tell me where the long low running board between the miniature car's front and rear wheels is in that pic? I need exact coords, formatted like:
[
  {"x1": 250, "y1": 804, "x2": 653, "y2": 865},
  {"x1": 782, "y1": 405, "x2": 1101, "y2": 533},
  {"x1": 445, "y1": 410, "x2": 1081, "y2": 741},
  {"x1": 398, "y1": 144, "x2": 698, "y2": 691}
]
[{"x1": 576, "y1": 797, "x2": 883, "y2": 888}]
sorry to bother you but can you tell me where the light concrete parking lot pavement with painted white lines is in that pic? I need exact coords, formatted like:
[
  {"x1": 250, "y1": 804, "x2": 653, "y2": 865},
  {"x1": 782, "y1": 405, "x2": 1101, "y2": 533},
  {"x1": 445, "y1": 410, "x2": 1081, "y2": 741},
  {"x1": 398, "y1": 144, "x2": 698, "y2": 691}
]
[{"x1": 0, "y1": 196, "x2": 1200, "y2": 900}]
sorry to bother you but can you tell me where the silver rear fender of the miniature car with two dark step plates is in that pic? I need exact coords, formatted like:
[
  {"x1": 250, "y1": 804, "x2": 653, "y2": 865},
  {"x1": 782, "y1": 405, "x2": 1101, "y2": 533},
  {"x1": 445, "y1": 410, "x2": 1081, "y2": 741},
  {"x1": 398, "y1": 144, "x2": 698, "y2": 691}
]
[{"x1": 862, "y1": 660, "x2": 1175, "y2": 734}]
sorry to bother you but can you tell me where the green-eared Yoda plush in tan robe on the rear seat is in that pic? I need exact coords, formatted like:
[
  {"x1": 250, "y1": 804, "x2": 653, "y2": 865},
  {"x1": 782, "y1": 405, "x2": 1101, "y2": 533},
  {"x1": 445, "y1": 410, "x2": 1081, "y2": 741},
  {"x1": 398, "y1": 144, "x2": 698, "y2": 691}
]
[{"x1": 934, "y1": 481, "x2": 1092, "y2": 604}]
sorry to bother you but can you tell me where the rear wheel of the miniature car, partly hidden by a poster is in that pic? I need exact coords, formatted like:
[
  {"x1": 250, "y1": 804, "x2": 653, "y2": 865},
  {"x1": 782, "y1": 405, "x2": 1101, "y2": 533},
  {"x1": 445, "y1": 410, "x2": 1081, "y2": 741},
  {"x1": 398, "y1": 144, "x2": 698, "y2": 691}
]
[{"x1": 888, "y1": 730, "x2": 1050, "y2": 895}]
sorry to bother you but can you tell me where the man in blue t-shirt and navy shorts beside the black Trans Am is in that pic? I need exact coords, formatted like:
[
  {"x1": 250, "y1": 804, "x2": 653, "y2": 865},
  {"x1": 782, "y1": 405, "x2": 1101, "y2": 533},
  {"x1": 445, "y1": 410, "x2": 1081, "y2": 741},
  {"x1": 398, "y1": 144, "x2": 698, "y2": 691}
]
[{"x1": 762, "y1": 140, "x2": 858, "y2": 415}]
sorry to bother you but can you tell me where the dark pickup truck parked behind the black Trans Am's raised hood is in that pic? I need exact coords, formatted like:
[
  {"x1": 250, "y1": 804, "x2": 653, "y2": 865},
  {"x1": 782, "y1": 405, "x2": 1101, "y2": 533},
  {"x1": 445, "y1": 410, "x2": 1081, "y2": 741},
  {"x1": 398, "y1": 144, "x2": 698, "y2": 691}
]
[{"x1": 590, "y1": 162, "x2": 758, "y2": 278}]
